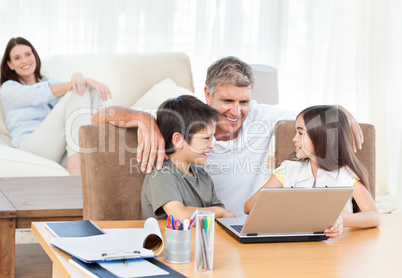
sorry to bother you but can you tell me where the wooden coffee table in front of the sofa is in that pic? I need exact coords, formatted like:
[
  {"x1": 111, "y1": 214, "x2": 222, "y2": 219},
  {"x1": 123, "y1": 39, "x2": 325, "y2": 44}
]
[{"x1": 0, "y1": 176, "x2": 82, "y2": 277}]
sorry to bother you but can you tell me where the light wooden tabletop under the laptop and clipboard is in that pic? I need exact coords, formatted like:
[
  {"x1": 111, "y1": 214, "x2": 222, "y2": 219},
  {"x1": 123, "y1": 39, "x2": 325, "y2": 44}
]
[{"x1": 32, "y1": 214, "x2": 402, "y2": 277}]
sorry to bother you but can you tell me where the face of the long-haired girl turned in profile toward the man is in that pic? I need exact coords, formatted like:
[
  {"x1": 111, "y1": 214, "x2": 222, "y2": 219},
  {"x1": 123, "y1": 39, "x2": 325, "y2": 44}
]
[{"x1": 293, "y1": 115, "x2": 315, "y2": 159}]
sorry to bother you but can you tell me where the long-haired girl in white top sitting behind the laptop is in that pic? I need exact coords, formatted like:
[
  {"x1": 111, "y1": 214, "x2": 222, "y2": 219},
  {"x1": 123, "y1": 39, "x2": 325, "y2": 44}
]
[{"x1": 244, "y1": 105, "x2": 380, "y2": 238}]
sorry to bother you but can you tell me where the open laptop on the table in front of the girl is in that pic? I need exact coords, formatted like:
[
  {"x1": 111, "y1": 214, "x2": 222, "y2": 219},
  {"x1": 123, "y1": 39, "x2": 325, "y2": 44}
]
[{"x1": 217, "y1": 186, "x2": 353, "y2": 243}]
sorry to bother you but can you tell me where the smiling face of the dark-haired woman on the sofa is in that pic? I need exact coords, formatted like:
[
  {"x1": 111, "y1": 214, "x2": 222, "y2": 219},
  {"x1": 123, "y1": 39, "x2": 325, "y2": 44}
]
[{"x1": 7, "y1": 44, "x2": 36, "y2": 85}]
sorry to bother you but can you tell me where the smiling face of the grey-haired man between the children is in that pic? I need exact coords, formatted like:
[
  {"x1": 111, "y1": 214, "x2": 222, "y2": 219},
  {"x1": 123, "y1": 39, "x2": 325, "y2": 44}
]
[{"x1": 204, "y1": 85, "x2": 251, "y2": 141}]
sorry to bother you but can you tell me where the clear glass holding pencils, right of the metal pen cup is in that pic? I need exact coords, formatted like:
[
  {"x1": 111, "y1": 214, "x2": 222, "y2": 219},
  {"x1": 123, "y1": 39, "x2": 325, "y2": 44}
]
[{"x1": 194, "y1": 211, "x2": 215, "y2": 272}]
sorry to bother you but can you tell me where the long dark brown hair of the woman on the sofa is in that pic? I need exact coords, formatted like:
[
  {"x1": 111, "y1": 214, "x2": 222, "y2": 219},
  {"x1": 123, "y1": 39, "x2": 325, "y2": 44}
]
[{"x1": 0, "y1": 37, "x2": 42, "y2": 84}]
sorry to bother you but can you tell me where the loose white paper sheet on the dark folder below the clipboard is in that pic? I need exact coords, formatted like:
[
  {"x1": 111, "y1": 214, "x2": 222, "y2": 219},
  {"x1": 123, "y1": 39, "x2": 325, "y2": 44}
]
[{"x1": 99, "y1": 259, "x2": 169, "y2": 278}]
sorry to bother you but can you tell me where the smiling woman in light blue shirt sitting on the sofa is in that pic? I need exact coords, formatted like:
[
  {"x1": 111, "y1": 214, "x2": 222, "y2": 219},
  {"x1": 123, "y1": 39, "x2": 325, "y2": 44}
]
[{"x1": 0, "y1": 37, "x2": 111, "y2": 175}]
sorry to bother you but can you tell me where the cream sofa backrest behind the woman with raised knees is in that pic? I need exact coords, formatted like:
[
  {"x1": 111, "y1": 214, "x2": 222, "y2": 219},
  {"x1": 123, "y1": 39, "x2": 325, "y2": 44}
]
[{"x1": 0, "y1": 52, "x2": 194, "y2": 144}]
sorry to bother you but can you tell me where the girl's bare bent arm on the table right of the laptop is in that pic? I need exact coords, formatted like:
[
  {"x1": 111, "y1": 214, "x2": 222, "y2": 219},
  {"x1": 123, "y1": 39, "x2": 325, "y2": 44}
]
[{"x1": 342, "y1": 181, "x2": 380, "y2": 228}]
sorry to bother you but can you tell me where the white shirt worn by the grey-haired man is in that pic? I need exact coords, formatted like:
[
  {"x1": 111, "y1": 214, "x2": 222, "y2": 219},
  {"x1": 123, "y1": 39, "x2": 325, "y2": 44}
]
[{"x1": 205, "y1": 100, "x2": 296, "y2": 217}]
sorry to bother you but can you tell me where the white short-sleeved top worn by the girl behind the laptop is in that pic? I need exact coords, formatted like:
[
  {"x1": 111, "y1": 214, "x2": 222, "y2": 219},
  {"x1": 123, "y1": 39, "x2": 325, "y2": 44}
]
[{"x1": 274, "y1": 159, "x2": 359, "y2": 213}]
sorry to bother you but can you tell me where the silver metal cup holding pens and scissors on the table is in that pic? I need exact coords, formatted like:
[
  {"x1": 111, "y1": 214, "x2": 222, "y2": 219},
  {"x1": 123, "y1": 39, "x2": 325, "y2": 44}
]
[{"x1": 165, "y1": 227, "x2": 192, "y2": 264}]
